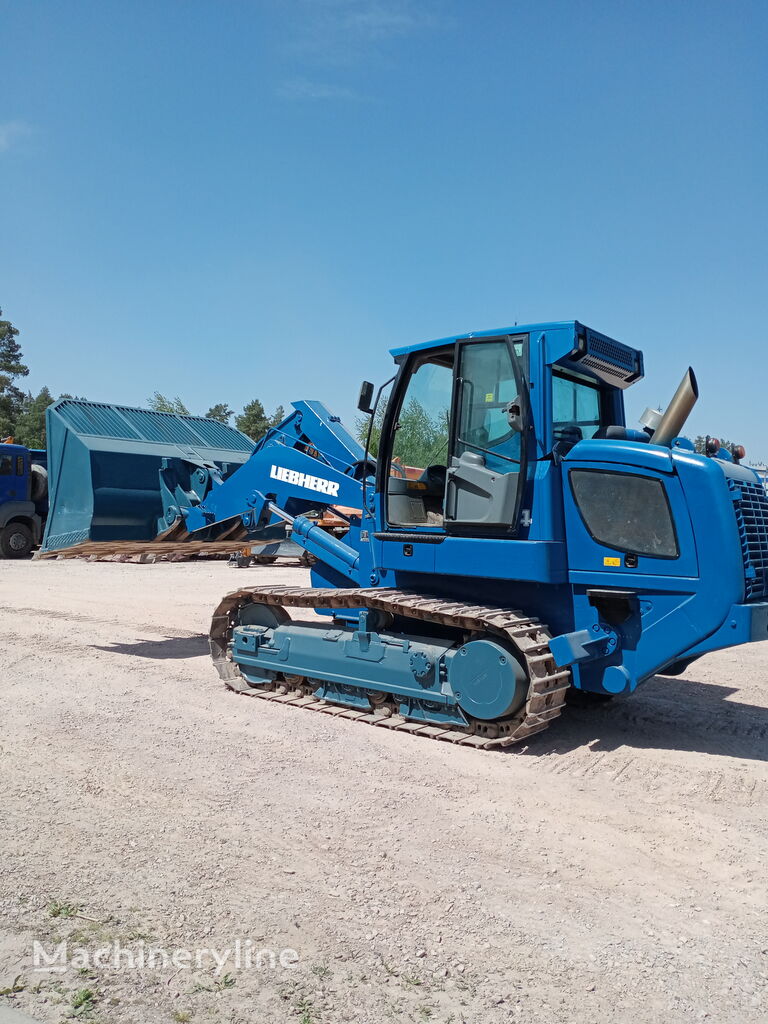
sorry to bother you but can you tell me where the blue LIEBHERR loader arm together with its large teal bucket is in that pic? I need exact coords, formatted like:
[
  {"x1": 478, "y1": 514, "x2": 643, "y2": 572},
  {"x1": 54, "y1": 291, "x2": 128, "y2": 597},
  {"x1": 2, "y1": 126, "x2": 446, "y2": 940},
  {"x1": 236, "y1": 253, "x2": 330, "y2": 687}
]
[{"x1": 44, "y1": 399, "x2": 373, "y2": 565}]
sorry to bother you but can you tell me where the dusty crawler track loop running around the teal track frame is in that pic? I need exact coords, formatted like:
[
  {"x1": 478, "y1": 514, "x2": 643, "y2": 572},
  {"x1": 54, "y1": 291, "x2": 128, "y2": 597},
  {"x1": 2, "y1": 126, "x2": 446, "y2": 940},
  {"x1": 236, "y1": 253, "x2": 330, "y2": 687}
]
[{"x1": 210, "y1": 587, "x2": 570, "y2": 750}]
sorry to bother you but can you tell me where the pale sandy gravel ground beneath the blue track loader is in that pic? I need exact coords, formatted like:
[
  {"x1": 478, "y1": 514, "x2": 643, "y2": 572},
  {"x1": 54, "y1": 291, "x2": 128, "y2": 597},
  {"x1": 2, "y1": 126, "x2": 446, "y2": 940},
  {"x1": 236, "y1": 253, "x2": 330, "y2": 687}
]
[{"x1": 0, "y1": 562, "x2": 768, "y2": 1024}]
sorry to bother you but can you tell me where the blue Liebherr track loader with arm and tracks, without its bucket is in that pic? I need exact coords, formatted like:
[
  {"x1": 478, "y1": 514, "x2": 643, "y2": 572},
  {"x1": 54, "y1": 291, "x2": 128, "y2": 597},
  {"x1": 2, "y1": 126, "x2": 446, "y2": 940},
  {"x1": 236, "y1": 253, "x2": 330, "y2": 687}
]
[{"x1": 193, "y1": 322, "x2": 768, "y2": 748}]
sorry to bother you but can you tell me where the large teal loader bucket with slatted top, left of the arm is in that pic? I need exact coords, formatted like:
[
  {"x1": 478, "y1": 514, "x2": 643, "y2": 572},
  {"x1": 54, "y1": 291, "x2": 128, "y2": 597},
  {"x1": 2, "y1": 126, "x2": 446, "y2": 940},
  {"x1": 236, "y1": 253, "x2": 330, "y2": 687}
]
[{"x1": 42, "y1": 398, "x2": 255, "y2": 551}]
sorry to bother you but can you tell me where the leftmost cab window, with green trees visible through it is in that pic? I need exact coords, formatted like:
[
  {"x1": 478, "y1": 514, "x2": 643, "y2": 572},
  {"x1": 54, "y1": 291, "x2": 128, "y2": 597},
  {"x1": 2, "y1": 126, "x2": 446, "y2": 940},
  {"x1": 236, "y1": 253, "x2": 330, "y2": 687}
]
[{"x1": 387, "y1": 349, "x2": 454, "y2": 526}]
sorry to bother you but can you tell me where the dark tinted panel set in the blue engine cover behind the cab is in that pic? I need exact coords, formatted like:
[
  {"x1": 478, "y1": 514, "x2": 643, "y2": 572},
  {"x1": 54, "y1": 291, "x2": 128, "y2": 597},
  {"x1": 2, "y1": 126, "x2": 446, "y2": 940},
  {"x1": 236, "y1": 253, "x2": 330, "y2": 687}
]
[{"x1": 570, "y1": 469, "x2": 680, "y2": 558}]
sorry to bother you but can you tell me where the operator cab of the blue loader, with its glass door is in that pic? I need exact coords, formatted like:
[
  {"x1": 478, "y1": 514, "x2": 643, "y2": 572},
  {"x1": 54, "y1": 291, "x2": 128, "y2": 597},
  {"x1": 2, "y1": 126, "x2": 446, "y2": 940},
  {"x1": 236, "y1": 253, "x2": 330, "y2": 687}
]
[{"x1": 368, "y1": 325, "x2": 641, "y2": 535}]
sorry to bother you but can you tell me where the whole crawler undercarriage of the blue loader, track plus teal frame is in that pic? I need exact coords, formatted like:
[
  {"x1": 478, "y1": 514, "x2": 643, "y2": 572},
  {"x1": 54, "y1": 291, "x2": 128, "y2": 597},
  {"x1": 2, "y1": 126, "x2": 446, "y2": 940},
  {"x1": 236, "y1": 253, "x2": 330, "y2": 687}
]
[{"x1": 210, "y1": 587, "x2": 570, "y2": 749}]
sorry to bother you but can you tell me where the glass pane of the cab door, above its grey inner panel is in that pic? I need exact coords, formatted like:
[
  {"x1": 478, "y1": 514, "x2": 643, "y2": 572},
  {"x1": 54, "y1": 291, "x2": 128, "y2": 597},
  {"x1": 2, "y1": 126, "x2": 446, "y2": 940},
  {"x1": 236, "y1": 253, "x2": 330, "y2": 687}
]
[{"x1": 455, "y1": 341, "x2": 521, "y2": 473}]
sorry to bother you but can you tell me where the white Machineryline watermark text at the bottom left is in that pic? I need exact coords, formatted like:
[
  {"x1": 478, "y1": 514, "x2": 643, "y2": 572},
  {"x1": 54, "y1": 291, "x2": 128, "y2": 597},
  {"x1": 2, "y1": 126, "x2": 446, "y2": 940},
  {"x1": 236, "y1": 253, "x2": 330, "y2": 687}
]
[{"x1": 32, "y1": 939, "x2": 299, "y2": 975}]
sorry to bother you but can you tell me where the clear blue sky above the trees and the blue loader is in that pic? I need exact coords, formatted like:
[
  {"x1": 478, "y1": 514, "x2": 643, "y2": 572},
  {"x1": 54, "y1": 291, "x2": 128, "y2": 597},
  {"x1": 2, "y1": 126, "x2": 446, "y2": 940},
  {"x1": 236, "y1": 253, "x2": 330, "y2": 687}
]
[{"x1": 0, "y1": 0, "x2": 768, "y2": 459}]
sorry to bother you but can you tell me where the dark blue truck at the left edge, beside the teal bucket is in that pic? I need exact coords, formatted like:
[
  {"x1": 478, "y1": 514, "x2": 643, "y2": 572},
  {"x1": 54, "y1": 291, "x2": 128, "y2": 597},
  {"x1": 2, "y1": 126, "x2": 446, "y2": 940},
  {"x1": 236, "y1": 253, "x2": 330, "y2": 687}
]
[{"x1": 0, "y1": 443, "x2": 48, "y2": 558}]
